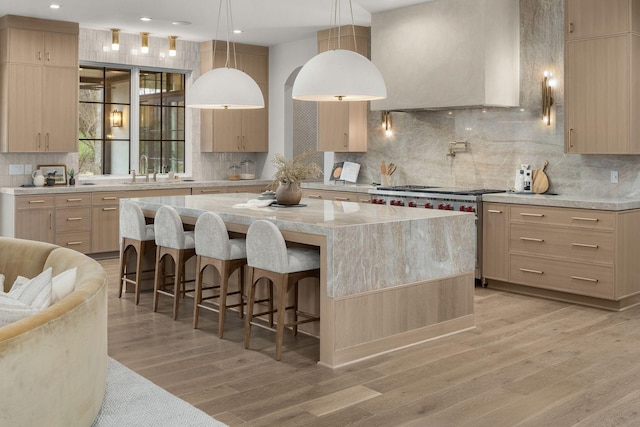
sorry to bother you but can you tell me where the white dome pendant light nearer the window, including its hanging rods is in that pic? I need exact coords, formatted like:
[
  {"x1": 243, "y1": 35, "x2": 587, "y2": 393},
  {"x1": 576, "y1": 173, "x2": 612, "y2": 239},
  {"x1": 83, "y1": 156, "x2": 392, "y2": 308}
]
[{"x1": 187, "y1": 0, "x2": 264, "y2": 109}]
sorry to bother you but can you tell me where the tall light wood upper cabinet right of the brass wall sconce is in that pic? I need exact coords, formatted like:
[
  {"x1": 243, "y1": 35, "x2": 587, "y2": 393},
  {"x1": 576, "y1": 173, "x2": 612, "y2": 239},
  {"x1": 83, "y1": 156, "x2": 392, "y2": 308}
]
[{"x1": 565, "y1": 0, "x2": 640, "y2": 154}]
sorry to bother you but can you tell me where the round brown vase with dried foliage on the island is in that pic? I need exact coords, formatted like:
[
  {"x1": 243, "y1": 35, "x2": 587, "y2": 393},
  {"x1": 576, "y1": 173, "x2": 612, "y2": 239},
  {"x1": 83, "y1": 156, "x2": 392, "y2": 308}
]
[{"x1": 271, "y1": 151, "x2": 322, "y2": 205}]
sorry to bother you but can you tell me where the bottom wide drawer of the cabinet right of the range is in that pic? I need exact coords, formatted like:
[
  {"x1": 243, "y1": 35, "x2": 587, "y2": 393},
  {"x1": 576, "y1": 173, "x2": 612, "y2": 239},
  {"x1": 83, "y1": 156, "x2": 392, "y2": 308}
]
[{"x1": 510, "y1": 255, "x2": 615, "y2": 299}]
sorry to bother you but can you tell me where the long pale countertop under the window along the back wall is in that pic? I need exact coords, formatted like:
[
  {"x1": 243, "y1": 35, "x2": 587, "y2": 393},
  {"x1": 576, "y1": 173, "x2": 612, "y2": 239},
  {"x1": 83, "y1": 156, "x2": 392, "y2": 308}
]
[{"x1": 0, "y1": 179, "x2": 271, "y2": 196}]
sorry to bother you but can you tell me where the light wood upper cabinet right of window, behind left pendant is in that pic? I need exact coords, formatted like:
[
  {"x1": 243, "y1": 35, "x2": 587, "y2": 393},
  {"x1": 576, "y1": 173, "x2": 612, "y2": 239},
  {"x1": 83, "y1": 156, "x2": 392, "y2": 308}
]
[{"x1": 200, "y1": 41, "x2": 269, "y2": 152}]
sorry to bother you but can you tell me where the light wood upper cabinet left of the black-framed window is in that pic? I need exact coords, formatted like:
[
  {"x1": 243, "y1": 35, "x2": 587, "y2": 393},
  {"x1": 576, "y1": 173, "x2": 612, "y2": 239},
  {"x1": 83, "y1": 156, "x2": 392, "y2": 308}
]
[{"x1": 0, "y1": 15, "x2": 79, "y2": 153}]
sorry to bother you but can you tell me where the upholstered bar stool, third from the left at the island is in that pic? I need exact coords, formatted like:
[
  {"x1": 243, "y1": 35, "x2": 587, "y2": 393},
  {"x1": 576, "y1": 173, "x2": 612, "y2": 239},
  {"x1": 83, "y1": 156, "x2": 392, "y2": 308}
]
[{"x1": 193, "y1": 212, "x2": 247, "y2": 338}]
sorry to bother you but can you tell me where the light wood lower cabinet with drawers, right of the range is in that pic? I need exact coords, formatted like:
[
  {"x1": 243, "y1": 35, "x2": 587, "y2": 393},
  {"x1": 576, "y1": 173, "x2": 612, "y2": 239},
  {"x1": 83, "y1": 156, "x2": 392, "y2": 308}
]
[{"x1": 483, "y1": 203, "x2": 640, "y2": 309}]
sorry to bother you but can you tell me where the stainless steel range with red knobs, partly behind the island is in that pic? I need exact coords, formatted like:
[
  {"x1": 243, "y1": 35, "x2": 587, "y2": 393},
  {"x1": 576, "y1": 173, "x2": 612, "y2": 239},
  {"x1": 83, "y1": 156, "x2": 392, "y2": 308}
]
[{"x1": 369, "y1": 185, "x2": 504, "y2": 280}]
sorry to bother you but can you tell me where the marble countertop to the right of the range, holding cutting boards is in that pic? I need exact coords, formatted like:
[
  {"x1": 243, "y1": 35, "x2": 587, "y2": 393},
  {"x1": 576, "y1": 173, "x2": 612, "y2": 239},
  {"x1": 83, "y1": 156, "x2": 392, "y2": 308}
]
[{"x1": 482, "y1": 193, "x2": 640, "y2": 211}]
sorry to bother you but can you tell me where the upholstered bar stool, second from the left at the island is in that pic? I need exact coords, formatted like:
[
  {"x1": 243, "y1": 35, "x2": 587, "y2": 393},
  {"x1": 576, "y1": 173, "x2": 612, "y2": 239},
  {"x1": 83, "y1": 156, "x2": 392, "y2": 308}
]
[{"x1": 153, "y1": 206, "x2": 196, "y2": 320}]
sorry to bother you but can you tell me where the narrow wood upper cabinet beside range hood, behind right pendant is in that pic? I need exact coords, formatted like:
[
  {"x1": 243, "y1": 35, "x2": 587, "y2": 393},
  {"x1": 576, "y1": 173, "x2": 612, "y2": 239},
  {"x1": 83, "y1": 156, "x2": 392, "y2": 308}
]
[{"x1": 318, "y1": 25, "x2": 370, "y2": 152}]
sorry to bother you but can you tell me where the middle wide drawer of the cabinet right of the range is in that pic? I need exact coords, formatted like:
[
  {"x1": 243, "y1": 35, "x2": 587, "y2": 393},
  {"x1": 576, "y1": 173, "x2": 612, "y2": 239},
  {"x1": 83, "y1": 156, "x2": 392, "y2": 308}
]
[{"x1": 510, "y1": 224, "x2": 614, "y2": 265}]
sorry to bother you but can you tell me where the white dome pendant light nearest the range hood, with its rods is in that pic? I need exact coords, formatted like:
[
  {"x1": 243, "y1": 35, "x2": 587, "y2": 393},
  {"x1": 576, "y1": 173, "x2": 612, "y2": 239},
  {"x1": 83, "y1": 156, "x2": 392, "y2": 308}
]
[{"x1": 292, "y1": 0, "x2": 387, "y2": 101}]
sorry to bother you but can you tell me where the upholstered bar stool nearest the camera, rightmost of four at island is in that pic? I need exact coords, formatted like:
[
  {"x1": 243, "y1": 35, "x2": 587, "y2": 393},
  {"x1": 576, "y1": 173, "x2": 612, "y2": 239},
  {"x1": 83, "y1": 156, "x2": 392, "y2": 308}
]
[{"x1": 244, "y1": 220, "x2": 320, "y2": 360}]
